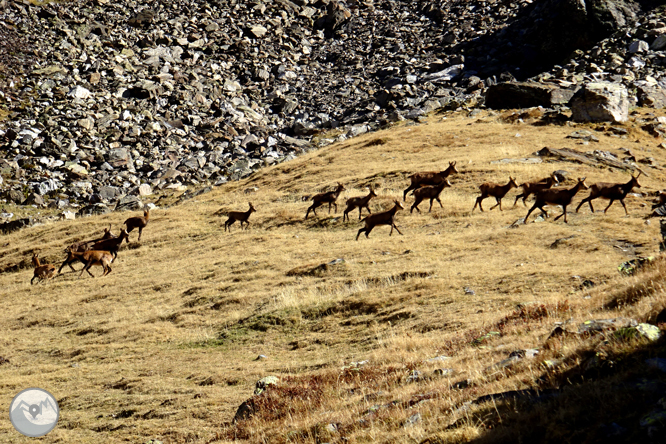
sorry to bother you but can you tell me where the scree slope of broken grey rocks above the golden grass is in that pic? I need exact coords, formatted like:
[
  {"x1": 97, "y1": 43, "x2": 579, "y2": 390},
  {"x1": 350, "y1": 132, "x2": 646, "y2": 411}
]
[{"x1": 0, "y1": 0, "x2": 666, "y2": 219}]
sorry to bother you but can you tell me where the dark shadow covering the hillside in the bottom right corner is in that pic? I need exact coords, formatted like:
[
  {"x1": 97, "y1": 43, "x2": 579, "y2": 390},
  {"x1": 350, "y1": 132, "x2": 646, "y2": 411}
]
[{"x1": 444, "y1": 337, "x2": 666, "y2": 444}]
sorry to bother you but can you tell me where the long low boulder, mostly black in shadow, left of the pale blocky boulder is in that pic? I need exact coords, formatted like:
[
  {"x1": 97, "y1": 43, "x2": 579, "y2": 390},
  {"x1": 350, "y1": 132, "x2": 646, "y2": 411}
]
[{"x1": 485, "y1": 82, "x2": 575, "y2": 109}]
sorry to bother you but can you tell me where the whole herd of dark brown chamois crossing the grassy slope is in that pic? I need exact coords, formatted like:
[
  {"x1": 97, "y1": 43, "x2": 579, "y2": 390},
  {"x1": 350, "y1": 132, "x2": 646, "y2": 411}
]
[{"x1": 30, "y1": 162, "x2": 644, "y2": 283}]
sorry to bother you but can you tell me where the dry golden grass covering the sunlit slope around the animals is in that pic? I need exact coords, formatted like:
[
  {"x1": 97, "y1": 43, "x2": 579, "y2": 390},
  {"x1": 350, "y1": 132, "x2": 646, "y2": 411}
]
[{"x1": 0, "y1": 111, "x2": 666, "y2": 443}]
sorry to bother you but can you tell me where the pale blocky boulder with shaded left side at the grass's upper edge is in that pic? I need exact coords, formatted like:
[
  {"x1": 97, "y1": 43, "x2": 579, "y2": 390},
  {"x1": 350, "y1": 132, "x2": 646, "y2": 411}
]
[{"x1": 569, "y1": 82, "x2": 629, "y2": 122}]
